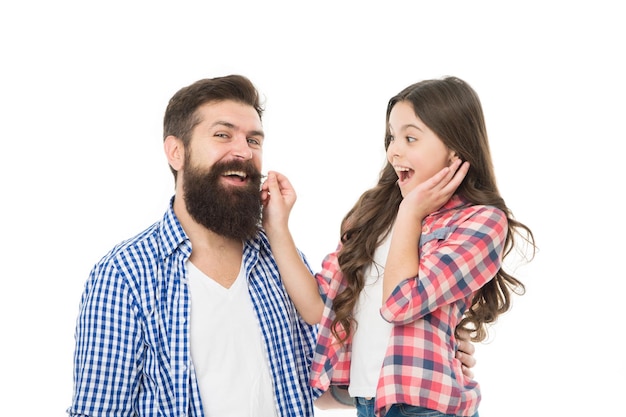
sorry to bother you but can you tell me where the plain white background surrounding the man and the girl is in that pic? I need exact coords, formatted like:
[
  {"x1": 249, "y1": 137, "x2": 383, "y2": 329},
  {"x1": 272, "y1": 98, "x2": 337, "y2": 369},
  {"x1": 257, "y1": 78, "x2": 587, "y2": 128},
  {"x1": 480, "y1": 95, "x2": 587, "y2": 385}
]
[{"x1": 0, "y1": 0, "x2": 626, "y2": 417}]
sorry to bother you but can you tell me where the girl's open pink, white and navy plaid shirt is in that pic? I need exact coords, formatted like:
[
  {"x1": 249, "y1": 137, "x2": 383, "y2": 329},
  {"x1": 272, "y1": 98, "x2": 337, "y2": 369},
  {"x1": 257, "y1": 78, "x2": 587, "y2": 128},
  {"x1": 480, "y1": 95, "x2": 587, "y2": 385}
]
[{"x1": 311, "y1": 196, "x2": 507, "y2": 416}]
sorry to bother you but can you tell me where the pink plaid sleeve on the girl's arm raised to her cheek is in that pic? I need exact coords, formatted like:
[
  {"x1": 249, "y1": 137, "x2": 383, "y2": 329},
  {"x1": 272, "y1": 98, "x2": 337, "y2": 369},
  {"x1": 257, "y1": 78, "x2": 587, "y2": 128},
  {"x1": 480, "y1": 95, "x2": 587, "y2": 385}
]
[{"x1": 380, "y1": 206, "x2": 507, "y2": 324}]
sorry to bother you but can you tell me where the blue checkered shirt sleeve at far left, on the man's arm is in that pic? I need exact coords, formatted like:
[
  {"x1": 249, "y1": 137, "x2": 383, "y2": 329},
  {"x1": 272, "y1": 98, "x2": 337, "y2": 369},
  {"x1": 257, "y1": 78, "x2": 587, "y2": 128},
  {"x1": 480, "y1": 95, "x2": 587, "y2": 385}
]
[{"x1": 68, "y1": 262, "x2": 141, "y2": 416}]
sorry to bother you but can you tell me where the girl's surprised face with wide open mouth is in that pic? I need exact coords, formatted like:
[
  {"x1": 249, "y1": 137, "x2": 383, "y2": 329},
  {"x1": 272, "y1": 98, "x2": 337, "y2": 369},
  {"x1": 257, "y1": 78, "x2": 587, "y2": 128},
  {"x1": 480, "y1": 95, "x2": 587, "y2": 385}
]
[{"x1": 387, "y1": 101, "x2": 455, "y2": 197}]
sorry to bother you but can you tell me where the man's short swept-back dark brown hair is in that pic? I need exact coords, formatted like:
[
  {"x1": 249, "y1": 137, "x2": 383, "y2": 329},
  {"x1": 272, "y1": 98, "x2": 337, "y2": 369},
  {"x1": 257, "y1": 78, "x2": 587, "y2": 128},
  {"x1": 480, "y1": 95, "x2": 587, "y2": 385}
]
[{"x1": 163, "y1": 74, "x2": 265, "y2": 178}]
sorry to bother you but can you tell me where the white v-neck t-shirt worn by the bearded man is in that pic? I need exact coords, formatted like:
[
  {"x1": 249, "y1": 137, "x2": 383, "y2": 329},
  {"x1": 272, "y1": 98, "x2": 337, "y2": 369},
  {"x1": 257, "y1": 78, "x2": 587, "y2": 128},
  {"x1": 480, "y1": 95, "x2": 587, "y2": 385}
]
[{"x1": 187, "y1": 262, "x2": 277, "y2": 417}]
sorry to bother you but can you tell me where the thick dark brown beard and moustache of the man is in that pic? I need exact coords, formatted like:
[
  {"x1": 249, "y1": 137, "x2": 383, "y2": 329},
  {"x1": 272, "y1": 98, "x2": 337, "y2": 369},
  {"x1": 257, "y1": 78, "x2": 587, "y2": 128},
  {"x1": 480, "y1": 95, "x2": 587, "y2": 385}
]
[{"x1": 183, "y1": 158, "x2": 262, "y2": 240}]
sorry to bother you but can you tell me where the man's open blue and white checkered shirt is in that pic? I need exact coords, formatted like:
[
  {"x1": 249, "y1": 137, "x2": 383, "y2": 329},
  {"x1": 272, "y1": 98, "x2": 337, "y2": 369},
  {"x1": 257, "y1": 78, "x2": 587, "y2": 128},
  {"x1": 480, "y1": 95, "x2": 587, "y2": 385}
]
[{"x1": 67, "y1": 199, "x2": 320, "y2": 417}]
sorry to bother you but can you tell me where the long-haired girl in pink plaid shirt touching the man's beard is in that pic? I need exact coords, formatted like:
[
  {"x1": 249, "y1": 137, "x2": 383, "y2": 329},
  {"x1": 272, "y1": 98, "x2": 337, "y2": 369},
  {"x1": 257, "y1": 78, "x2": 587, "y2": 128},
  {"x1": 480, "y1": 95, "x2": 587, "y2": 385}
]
[{"x1": 262, "y1": 77, "x2": 535, "y2": 417}]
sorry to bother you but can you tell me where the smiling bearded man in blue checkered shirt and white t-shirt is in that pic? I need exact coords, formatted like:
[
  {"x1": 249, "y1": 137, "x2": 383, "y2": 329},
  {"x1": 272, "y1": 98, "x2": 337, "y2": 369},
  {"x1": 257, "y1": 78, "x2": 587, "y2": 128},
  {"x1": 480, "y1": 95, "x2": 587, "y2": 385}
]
[{"x1": 67, "y1": 75, "x2": 321, "y2": 417}]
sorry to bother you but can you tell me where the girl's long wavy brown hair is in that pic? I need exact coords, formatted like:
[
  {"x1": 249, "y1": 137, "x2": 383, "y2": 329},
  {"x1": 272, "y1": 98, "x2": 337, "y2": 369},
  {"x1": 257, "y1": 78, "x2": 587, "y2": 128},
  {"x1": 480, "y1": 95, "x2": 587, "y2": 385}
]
[{"x1": 331, "y1": 77, "x2": 536, "y2": 343}]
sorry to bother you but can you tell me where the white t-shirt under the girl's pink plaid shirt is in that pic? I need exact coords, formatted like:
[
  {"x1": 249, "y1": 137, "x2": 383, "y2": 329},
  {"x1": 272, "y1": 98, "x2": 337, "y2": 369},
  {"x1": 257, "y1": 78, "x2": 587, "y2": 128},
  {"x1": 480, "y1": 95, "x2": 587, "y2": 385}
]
[{"x1": 348, "y1": 233, "x2": 393, "y2": 398}]
